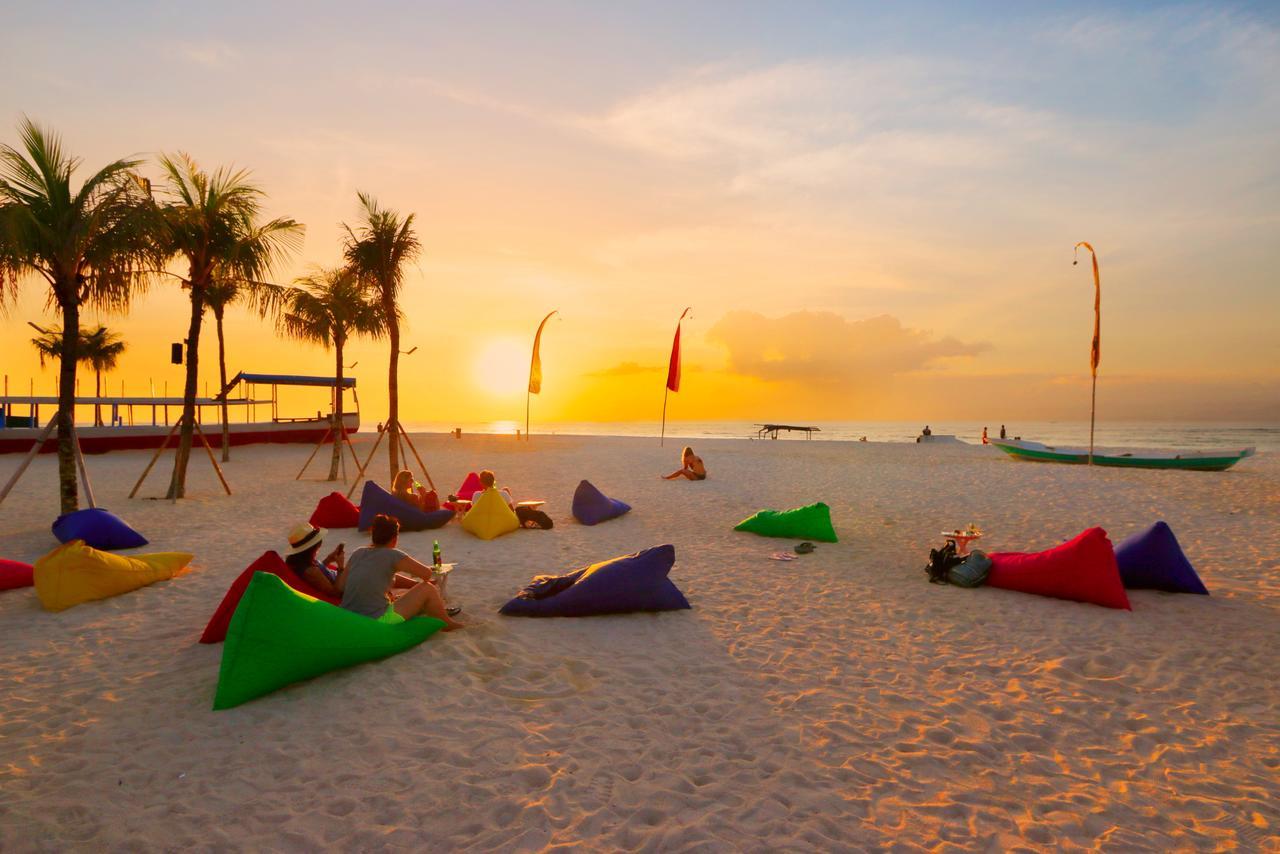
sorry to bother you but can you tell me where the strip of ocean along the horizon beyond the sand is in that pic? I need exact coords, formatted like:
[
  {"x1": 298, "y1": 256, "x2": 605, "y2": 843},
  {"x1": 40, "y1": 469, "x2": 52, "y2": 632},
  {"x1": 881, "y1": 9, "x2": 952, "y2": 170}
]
[{"x1": 401, "y1": 421, "x2": 1280, "y2": 451}]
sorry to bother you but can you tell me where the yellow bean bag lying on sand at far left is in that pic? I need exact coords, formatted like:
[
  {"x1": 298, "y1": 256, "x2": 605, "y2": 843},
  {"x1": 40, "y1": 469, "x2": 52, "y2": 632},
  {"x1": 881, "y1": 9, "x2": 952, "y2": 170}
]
[{"x1": 35, "y1": 540, "x2": 195, "y2": 611}]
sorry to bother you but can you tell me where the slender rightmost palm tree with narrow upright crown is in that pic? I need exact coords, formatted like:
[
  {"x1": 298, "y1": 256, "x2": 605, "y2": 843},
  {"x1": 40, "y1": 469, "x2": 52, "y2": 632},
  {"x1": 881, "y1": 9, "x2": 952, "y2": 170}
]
[{"x1": 343, "y1": 193, "x2": 422, "y2": 479}]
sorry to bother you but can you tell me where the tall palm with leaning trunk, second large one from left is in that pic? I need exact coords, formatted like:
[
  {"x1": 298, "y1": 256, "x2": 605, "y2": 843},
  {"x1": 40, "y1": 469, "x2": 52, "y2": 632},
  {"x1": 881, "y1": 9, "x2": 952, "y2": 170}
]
[{"x1": 160, "y1": 154, "x2": 302, "y2": 498}]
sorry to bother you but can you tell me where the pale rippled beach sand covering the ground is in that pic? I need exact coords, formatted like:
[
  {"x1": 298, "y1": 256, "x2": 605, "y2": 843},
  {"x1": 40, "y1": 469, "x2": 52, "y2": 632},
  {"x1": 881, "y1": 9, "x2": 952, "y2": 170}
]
[{"x1": 0, "y1": 437, "x2": 1280, "y2": 850}]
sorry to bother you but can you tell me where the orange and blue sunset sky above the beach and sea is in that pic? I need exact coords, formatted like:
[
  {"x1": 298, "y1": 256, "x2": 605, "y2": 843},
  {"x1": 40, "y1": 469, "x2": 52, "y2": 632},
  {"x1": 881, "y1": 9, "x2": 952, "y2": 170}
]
[{"x1": 0, "y1": 1, "x2": 1280, "y2": 423}]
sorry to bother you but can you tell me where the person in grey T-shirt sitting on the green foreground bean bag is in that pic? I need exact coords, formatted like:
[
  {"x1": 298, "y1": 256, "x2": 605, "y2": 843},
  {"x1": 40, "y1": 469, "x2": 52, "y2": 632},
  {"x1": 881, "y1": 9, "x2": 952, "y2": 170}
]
[{"x1": 342, "y1": 513, "x2": 463, "y2": 631}]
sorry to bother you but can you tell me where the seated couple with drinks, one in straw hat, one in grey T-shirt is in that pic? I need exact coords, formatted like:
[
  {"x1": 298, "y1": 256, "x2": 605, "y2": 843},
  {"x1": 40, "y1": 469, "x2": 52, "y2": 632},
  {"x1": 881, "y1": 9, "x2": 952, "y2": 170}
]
[{"x1": 284, "y1": 513, "x2": 465, "y2": 631}]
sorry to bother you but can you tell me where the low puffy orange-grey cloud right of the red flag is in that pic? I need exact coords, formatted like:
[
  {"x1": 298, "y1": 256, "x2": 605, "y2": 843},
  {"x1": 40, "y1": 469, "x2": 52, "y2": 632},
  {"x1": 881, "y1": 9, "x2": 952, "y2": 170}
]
[{"x1": 707, "y1": 311, "x2": 988, "y2": 384}]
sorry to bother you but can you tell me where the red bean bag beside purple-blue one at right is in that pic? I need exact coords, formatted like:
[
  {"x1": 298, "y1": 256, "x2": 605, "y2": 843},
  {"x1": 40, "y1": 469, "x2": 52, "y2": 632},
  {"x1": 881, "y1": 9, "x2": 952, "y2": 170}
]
[{"x1": 987, "y1": 528, "x2": 1133, "y2": 611}]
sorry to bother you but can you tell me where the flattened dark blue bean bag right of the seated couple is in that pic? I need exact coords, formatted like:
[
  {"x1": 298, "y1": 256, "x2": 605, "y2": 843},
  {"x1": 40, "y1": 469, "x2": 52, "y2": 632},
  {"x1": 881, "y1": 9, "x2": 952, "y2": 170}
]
[{"x1": 499, "y1": 545, "x2": 690, "y2": 617}]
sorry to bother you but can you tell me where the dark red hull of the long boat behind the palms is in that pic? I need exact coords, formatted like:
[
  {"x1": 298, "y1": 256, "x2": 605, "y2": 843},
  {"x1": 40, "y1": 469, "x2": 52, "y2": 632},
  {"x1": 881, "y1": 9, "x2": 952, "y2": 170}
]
[{"x1": 0, "y1": 412, "x2": 360, "y2": 453}]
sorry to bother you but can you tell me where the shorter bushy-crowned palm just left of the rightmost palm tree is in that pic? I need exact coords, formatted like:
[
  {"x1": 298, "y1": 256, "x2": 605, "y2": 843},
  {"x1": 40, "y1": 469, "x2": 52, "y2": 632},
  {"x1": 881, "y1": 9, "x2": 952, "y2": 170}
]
[{"x1": 280, "y1": 268, "x2": 385, "y2": 480}]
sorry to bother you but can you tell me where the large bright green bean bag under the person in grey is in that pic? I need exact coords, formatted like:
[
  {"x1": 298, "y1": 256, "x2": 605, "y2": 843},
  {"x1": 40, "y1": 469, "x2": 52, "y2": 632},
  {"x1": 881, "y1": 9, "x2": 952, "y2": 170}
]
[{"x1": 214, "y1": 572, "x2": 444, "y2": 709}]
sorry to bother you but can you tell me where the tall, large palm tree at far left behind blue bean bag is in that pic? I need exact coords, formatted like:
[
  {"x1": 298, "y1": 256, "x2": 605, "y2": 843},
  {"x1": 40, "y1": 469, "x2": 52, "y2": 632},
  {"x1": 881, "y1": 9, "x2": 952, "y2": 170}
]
[{"x1": 0, "y1": 119, "x2": 156, "y2": 513}]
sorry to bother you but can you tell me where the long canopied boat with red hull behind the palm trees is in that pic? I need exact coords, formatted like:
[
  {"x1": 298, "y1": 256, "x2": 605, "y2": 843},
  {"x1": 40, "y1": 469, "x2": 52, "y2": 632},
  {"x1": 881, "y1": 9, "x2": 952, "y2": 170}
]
[{"x1": 0, "y1": 373, "x2": 360, "y2": 453}]
